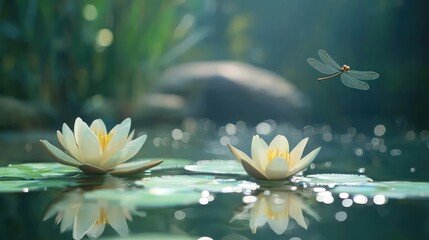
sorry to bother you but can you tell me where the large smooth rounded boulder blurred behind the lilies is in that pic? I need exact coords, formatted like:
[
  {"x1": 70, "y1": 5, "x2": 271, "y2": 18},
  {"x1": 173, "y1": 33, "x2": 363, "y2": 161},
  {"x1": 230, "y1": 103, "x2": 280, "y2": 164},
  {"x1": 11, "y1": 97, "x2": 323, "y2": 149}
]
[{"x1": 142, "y1": 61, "x2": 309, "y2": 123}]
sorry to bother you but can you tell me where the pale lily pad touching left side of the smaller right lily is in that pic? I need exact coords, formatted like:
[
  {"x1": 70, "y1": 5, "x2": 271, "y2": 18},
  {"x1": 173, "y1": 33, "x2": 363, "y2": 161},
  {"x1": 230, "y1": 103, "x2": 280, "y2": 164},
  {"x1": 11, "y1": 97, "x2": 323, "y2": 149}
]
[{"x1": 185, "y1": 160, "x2": 247, "y2": 175}]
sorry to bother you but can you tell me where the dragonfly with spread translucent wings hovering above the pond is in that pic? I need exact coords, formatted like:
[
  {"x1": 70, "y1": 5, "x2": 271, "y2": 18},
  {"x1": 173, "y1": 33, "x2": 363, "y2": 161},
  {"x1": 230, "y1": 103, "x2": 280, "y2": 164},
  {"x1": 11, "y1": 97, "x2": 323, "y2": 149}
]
[{"x1": 307, "y1": 49, "x2": 380, "y2": 90}]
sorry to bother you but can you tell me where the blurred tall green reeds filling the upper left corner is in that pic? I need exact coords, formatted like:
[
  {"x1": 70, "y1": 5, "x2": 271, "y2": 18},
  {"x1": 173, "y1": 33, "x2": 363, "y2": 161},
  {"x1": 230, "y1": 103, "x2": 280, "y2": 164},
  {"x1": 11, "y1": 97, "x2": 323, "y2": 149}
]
[{"x1": 0, "y1": 0, "x2": 192, "y2": 119}]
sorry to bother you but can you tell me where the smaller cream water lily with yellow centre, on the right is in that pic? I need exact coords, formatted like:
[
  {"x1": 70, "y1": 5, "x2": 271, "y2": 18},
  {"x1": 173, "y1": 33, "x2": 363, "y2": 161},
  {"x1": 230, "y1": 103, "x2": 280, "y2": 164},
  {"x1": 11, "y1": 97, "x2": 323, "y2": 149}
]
[{"x1": 228, "y1": 135, "x2": 320, "y2": 180}]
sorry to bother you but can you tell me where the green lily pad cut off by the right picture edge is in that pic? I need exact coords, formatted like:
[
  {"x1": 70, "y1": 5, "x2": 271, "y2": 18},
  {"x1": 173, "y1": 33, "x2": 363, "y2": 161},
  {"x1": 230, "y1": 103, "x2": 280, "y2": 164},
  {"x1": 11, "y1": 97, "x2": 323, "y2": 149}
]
[{"x1": 332, "y1": 181, "x2": 429, "y2": 199}]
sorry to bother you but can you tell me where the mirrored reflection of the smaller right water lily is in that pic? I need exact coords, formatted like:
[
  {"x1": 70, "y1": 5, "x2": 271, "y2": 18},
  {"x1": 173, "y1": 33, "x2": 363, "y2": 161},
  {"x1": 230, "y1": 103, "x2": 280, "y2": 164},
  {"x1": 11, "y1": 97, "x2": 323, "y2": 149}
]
[{"x1": 231, "y1": 190, "x2": 320, "y2": 235}]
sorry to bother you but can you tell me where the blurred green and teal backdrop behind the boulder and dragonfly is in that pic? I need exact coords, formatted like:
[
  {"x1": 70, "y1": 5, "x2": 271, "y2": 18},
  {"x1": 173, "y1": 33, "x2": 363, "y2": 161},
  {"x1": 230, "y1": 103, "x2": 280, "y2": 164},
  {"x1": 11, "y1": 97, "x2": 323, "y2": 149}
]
[{"x1": 0, "y1": 0, "x2": 429, "y2": 130}]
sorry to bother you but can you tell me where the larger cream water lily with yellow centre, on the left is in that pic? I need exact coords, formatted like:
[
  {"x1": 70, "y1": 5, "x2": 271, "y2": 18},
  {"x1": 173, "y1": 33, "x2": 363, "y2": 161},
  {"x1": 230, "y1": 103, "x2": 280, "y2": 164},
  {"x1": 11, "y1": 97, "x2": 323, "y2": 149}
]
[{"x1": 41, "y1": 118, "x2": 162, "y2": 174}]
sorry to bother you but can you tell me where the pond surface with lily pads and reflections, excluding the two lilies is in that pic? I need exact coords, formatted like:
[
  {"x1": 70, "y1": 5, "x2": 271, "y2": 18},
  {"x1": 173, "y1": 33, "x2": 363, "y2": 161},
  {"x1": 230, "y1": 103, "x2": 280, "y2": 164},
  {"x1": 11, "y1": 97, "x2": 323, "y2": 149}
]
[{"x1": 0, "y1": 120, "x2": 429, "y2": 240}]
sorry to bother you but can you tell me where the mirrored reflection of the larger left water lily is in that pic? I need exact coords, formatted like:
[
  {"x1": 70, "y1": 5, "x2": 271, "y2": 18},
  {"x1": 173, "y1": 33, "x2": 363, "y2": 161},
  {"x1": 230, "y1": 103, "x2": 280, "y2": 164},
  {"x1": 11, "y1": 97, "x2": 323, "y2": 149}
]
[{"x1": 43, "y1": 178, "x2": 141, "y2": 239}]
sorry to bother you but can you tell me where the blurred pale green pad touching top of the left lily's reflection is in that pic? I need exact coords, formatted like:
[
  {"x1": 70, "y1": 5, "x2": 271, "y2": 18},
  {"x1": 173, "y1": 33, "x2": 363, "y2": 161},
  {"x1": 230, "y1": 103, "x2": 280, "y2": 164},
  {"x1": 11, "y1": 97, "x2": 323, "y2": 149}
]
[{"x1": 84, "y1": 189, "x2": 201, "y2": 207}]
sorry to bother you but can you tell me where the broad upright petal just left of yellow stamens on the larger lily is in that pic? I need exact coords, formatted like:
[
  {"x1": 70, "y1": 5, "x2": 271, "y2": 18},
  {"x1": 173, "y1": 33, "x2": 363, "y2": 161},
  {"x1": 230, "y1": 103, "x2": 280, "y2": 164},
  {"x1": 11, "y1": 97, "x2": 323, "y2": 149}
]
[{"x1": 78, "y1": 123, "x2": 102, "y2": 167}]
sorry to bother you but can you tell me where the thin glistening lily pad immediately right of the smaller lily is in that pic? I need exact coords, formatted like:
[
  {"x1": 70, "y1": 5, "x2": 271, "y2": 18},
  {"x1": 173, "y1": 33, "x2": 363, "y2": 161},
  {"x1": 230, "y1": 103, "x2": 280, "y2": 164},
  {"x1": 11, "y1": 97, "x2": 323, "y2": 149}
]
[{"x1": 291, "y1": 174, "x2": 372, "y2": 186}]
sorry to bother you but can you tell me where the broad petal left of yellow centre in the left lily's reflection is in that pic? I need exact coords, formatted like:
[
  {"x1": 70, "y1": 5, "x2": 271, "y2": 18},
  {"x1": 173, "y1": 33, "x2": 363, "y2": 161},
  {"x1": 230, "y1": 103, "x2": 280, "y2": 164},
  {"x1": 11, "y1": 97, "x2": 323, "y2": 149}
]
[{"x1": 73, "y1": 203, "x2": 100, "y2": 239}]
